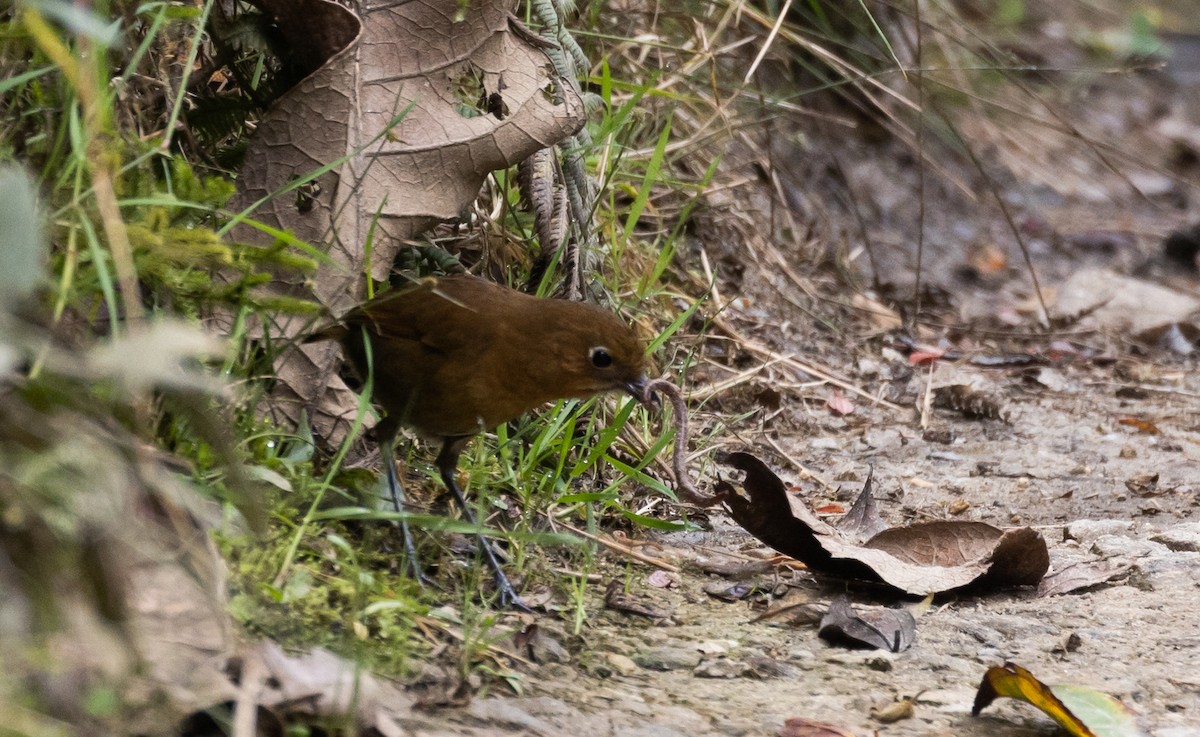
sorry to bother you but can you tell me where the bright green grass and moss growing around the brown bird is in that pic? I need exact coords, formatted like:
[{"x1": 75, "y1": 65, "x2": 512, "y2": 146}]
[{"x1": 0, "y1": 0, "x2": 716, "y2": 735}]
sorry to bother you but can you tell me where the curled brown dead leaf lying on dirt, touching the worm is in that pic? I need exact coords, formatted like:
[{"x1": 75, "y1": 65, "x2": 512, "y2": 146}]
[{"x1": 718, "y1": 453, "x2": 1050, "y2": 595}]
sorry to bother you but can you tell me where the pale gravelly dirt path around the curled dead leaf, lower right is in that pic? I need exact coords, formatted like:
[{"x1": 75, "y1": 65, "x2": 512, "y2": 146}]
[{"x1": 432, "y1": 381, "x2": 1200, "y2": 737}]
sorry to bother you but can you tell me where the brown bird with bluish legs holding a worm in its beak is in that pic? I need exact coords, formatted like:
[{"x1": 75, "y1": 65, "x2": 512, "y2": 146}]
[{"x1": 305, "y1": 275, "x2": 646, "y2": 609}]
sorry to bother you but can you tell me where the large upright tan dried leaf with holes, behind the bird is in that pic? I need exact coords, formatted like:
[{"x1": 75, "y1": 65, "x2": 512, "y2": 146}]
[{"x1": 228, "y1": 0, "x2": 584, "y2": 444}]
